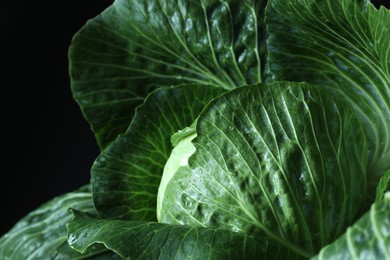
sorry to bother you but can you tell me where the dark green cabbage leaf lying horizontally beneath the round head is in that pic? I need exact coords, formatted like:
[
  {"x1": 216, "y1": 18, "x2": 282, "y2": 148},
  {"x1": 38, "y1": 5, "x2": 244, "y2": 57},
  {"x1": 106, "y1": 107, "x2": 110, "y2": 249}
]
[{"x1": 68, "y1": 212, "x2": 298, "y2": 260}]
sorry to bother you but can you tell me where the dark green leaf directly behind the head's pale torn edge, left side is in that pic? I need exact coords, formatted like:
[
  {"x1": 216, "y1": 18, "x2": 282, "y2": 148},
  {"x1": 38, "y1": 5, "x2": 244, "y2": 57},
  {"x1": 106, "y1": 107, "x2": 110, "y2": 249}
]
[{"x1": 91, "y1": 85, "x2": 224, "y2": 221}]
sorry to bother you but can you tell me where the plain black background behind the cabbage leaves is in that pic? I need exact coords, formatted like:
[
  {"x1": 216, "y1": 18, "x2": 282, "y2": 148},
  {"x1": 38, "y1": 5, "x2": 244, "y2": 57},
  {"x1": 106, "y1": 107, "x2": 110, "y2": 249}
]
[{"x1": 0, "y1": 0, "x2": 390, "y2": 236}]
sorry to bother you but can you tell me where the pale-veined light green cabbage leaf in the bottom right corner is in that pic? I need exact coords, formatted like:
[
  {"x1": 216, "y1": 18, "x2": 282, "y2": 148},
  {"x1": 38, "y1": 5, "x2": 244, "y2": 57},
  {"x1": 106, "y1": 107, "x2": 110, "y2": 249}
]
[{"x1": 314, "y1": 192, "x2": 390, "y2": 260}]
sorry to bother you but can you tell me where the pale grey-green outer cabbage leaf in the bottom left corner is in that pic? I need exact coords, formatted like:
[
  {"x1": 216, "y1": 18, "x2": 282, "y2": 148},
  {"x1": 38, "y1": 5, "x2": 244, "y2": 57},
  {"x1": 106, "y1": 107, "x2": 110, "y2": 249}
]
[{"x1": 0, "y1": 186, "x2": 118, "y2": 259}]
